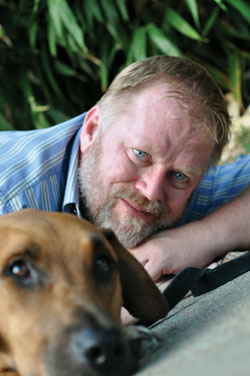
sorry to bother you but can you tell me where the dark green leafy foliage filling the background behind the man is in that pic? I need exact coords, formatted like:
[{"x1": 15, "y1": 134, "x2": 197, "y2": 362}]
[{"x1": 0, "y1": 0, "x2": 250, "y2": 130}]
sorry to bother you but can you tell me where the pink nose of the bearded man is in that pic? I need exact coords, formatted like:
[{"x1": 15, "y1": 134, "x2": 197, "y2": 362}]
[{"x1": 135, "y1": 171, "x2": 166, "y2": 201}]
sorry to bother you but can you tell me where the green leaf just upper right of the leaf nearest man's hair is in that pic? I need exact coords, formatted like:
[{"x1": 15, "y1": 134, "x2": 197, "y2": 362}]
[{"x1": 164, "y1": 7, "x2": 202, "y2": 41}]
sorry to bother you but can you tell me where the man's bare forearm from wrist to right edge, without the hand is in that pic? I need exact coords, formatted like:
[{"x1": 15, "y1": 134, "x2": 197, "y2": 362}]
[{"x1": 172, "y1": 186, "x2": 250, "y2": 267}]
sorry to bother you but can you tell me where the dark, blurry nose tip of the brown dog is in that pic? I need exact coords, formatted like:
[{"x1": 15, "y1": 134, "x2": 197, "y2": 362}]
[{"x1": 72, "y1": 328, "x2": 132, "y2": 375}]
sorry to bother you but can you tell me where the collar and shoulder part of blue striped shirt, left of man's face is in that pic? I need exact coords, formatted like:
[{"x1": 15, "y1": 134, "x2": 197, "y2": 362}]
[{"x1": 0, "y1": 114, "x2": 85, "y2": 214}]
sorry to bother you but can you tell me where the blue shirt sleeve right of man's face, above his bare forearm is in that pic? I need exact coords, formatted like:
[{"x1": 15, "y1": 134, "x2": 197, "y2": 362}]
[{"x1": 182, "y1": 155, "x2": 250, "y2": 224}]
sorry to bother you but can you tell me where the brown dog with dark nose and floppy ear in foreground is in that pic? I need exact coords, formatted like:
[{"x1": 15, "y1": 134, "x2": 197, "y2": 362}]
[{"x1": 0, "y1": 209, "x2": 168, "y2": 376}]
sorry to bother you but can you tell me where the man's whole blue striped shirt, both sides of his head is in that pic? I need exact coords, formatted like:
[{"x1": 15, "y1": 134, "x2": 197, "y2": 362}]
[{"x1": 0, "y1": 114, "x2": 250, "y2": 223}]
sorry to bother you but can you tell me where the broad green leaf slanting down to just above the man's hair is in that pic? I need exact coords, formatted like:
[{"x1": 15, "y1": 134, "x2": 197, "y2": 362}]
[{"x1": 146, "y1": 23, "x2": 182, "y2": 56}]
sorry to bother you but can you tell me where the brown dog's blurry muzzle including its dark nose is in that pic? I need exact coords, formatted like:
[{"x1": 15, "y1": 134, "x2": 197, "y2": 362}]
[{"x1": 45, "y1": 310, "x2": 140, "y2": 376}]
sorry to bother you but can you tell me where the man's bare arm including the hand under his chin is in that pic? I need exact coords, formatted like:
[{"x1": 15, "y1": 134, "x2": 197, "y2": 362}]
[{"x1": 130, "y1": 185, "x2": 250, "y2": 280}]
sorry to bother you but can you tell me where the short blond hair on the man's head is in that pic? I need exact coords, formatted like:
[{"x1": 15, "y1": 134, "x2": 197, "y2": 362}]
[{"x1": 98, "y1": 55, "x2": 231, "y2": 165}]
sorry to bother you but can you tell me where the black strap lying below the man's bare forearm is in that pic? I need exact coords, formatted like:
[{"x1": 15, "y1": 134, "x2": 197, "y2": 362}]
[{"x1": 163, "y1": 252, "x2": 250, "y2": 309}]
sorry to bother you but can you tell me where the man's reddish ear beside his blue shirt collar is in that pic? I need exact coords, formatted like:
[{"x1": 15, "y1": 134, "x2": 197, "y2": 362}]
[{"x1": 80, "y1": 105, "x2": 100, "y2": 154}]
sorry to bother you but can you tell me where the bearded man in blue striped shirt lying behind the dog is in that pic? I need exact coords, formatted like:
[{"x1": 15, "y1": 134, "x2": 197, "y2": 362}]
[{"x1": 0, "y1": 56, "x2": 250, "y2": 280}]
